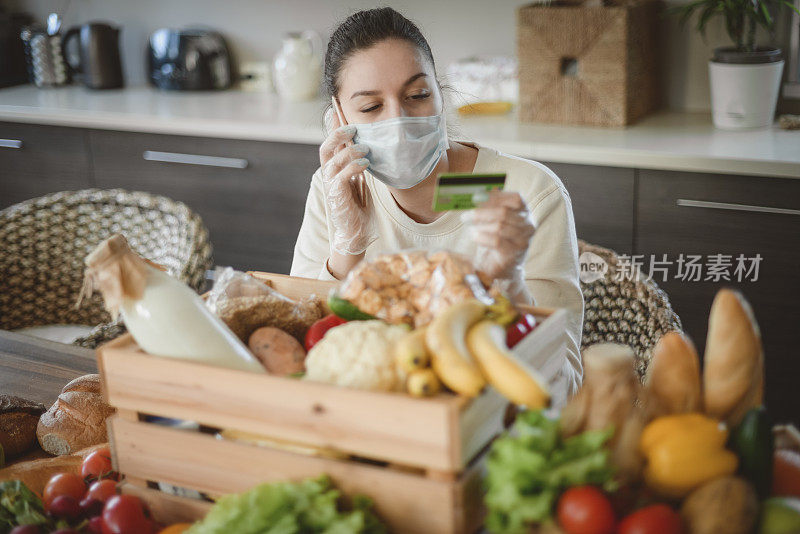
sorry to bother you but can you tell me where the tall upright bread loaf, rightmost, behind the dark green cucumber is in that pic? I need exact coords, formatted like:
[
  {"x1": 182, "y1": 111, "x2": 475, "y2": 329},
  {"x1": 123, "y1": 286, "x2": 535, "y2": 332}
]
[{"x1": 703, "y1": 289, "x2": 764, "y2": 427}]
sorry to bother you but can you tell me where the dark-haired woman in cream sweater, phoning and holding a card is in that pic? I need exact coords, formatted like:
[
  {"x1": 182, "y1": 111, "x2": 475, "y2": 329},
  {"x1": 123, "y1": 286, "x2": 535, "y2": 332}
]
[{"x1": 291, "y1": 8, "x2": 583, "y2": 398}]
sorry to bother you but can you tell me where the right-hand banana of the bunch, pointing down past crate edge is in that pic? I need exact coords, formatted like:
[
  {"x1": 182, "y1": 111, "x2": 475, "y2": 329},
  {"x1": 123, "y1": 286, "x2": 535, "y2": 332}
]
[{"x1": 467, "y1": 320, "x2": 550, "y2": 410}]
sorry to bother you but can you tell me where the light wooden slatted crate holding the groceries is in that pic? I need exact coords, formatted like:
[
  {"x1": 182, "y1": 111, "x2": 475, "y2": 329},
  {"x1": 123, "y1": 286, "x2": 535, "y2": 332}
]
[{"x1": 97, "y1": 273, "x2": 566, "y2": 534}]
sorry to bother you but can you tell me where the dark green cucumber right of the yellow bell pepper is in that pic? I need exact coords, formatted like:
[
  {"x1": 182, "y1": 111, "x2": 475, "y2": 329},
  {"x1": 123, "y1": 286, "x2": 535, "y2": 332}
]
[{"x1": 731, "y1": 406, "x2": 775, "y2": 498}]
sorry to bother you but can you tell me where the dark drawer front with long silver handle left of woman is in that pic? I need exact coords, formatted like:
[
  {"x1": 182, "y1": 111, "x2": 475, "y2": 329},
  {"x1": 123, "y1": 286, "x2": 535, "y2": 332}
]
[{"x1": 90, "y1": 130, "x2": 319, "y2": 273}]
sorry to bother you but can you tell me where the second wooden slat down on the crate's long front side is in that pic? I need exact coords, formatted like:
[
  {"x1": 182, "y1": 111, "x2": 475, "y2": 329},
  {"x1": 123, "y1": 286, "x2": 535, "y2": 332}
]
[{"x1": 112, "y1": 416, "x2": 483, "y2": 534}]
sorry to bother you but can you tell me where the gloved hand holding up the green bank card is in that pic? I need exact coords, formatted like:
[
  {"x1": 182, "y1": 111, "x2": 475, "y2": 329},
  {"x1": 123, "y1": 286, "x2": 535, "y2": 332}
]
[{"x1": 461, "y1": 191, "x2": 536, "y2": 293}]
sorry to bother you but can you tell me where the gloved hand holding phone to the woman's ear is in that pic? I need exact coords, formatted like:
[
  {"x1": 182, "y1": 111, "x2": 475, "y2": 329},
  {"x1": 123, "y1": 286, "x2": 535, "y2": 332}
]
[{"x1": 319, "y1": 110, "x2": 375, "y2": 255}]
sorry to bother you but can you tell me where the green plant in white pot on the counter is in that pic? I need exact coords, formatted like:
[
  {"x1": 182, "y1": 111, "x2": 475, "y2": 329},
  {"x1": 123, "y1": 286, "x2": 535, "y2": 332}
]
[{"x1": 673, "y1": 0, "x2": 797, "y2": 129}]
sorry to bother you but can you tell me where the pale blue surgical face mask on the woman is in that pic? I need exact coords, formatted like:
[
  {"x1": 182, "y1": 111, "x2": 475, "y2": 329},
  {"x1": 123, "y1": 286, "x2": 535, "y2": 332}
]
[{"x1": 353, "y1": 113, "x2": 449, "y2": 189}]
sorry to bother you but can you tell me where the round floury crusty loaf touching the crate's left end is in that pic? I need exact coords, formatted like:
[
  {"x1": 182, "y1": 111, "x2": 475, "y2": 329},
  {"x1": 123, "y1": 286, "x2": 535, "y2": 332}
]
[{"x1": 36, "y1": 375, "x2": 114, "y2": 455}]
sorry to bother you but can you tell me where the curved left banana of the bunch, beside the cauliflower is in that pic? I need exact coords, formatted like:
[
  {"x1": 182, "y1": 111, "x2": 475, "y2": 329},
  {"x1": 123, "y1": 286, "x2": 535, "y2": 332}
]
[{"x1": 425, "y1": 299, "x2": 486, "y2": 397}]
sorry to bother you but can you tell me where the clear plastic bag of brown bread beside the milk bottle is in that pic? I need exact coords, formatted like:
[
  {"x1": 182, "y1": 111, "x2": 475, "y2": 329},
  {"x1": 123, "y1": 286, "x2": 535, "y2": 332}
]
[{"x1": 206, "y1": 267, "x2": 325, "y2": 343}]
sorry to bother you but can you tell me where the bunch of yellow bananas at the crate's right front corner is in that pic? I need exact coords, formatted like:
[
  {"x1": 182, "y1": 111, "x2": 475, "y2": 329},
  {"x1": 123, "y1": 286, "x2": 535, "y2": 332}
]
[{"x1": 395, "y1": 299, "x2": 550, "y2": 409}]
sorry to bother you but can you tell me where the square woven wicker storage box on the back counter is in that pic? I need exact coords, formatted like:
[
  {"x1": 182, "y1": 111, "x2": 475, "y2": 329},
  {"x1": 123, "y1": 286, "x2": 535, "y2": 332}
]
[{"x1": 517, "y1": 0, "x2": 658, "y2": 126}]
